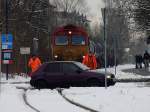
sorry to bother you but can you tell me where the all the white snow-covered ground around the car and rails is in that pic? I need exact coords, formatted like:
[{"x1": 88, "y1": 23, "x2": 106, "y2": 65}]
[{"x1": 0, "y1": 65, "x2": 150, "y2": 112}]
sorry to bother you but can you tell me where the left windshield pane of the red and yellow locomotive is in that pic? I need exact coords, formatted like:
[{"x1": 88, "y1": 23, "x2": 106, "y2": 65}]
[{"x1": 55, "y1": 36, "x2": 68, "y2": 45}]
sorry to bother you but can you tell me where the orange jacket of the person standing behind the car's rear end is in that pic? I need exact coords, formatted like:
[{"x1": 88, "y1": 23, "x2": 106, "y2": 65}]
[{"x1": 28, "y1": 55, "x2": 41, "y2": 72}]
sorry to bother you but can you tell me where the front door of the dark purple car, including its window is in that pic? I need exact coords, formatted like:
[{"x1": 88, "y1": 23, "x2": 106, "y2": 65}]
[{"x1": 62, "y1": 63, "x2": 84, "y2": 85}]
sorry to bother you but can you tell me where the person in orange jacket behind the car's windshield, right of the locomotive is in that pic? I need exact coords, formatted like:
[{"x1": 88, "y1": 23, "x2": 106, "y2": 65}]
[{"x1": 82, "y1": 51, "x2": 97, "y2": 69}]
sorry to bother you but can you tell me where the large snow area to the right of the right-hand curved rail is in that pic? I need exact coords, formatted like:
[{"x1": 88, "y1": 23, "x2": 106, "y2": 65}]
[{"x1": 63, "y1": 83, "x2": 150, "y2": 112}]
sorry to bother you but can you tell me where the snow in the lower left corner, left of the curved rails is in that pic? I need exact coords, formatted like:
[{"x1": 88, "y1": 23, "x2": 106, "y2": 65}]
[{"x1": 0, "y1": 84, "x2": 33, "y2": 112}]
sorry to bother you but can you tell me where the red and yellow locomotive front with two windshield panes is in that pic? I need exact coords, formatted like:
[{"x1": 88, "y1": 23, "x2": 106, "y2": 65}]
[{"x1": 52, "y1": 25, "x2": 89, "y2": 62}]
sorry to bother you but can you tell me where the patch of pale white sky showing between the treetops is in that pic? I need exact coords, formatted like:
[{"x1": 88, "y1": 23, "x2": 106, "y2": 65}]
[{"x1": 86, "y1": 0, "x2": 104, "y2": 23}]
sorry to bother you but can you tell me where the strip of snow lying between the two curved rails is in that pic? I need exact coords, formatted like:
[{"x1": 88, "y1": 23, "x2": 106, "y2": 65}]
[{"x1": 27, "y1": 89, "x2": 87, "y2": 112}]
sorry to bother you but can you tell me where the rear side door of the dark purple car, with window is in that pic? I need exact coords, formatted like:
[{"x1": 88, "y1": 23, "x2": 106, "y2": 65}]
[{"x1": 44, "y1": 63, "x2": 64, "y2": 86}]
